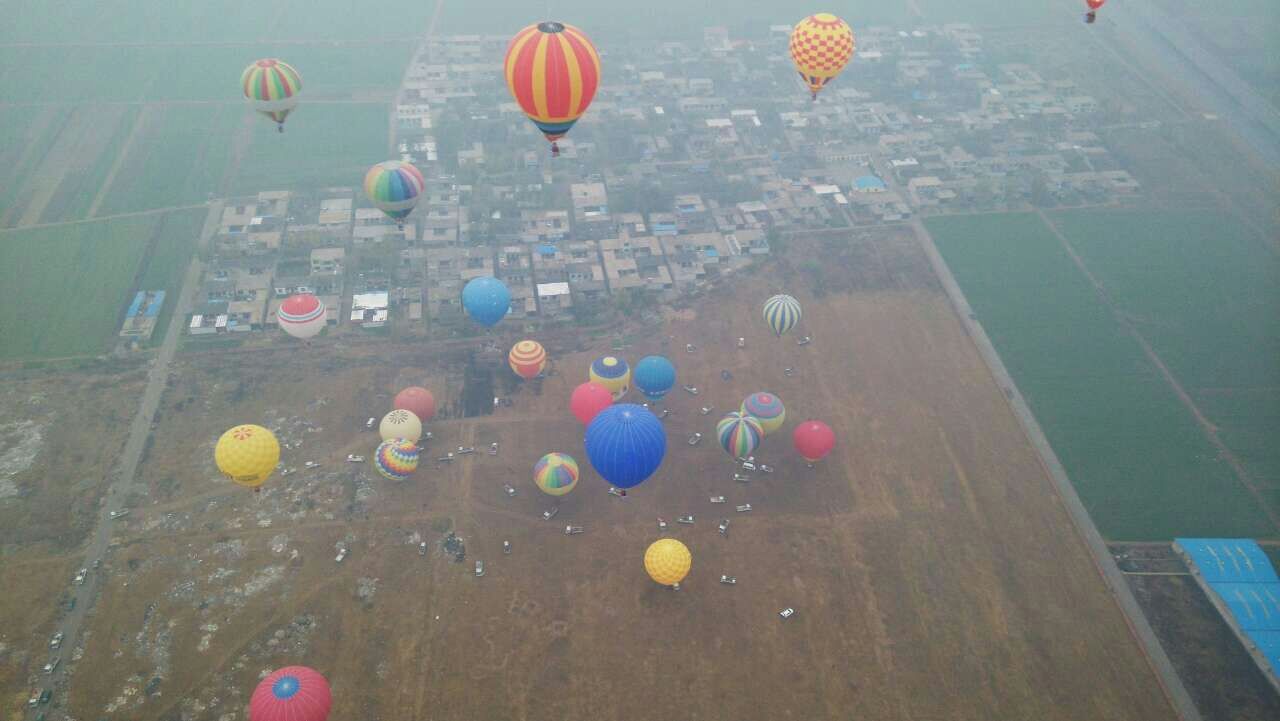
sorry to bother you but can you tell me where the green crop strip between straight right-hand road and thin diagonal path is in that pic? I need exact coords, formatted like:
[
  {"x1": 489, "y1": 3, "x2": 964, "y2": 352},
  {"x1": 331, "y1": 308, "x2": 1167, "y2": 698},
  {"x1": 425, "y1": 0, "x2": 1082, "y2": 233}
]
[{"x1": 927, "y1": 214, "x2": 1276, "y2": 540}]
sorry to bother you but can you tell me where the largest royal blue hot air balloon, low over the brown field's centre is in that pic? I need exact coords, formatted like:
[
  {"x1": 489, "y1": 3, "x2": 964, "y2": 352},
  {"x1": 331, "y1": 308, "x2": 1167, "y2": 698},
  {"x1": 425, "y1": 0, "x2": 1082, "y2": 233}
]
[{"x1": 586, "y1": 403, "x2": 667, "y2": 488}]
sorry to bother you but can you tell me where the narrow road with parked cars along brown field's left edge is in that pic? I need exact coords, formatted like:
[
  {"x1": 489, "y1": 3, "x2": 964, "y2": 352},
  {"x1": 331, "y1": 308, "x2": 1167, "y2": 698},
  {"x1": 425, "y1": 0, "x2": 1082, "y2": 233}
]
[{"x1": 28, "y1": 201, "x2": 223, "y2": 718}]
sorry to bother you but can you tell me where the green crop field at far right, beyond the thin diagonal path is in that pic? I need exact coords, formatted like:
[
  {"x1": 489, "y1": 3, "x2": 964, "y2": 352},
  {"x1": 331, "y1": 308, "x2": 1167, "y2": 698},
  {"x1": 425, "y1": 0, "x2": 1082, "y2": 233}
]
[{"x1": 1053, "y1": 211, "x2": 1280, "y2": 507}]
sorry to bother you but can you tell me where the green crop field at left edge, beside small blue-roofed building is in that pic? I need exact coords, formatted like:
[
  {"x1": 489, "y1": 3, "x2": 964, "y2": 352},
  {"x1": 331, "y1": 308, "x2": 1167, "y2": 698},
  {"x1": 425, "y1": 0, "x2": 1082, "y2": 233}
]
[{"x1": 0, "y1": 209, "x2": 205, "y2": 360}]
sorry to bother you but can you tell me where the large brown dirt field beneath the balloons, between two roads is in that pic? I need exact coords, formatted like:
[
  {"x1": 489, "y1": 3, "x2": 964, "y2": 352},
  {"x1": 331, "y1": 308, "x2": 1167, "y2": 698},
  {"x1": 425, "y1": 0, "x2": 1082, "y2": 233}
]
[{"x1": 70, "y1": 233, "x2": 1172, "y2": 721}]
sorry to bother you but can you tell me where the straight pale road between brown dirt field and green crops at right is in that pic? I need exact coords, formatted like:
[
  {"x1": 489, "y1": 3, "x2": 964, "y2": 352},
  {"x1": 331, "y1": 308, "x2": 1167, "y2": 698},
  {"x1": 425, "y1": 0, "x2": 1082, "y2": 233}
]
[{"x1": 911, "y1": 219, "x2": 1201, "y2": 721}]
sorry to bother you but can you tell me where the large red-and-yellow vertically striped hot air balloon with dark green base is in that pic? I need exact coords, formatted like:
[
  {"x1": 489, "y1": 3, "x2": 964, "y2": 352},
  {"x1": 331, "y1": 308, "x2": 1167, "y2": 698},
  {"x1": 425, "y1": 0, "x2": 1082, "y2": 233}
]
[{"x1": 503, "y1": 22, "x2": 600, "y2": 156}]
